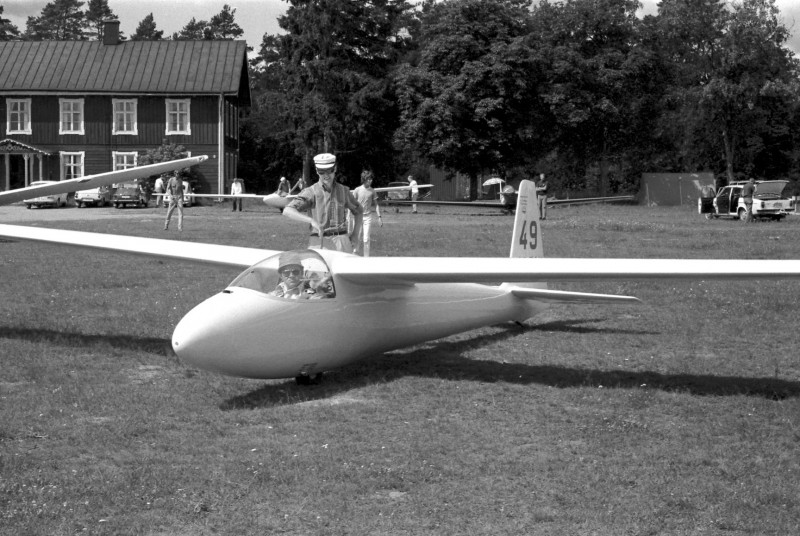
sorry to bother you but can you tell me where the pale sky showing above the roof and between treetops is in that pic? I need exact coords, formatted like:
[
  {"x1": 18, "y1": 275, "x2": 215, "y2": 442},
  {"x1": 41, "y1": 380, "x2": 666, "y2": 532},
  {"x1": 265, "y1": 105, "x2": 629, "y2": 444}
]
[{"x1": 0, "y1": 0, "x2": 800, "y2": 53}]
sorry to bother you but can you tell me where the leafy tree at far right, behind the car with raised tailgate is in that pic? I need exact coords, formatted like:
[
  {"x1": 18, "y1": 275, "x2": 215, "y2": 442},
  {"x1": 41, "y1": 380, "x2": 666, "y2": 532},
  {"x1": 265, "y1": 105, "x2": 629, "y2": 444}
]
[{"x1": 659, "y1": 0, "x2": 798, "y2": 180}]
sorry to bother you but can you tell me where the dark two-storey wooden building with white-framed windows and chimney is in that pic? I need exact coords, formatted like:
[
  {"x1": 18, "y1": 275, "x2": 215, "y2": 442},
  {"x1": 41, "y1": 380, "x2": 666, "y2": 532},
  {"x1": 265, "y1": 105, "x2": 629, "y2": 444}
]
[{"x1": 0, "y1": 21, "x2": 250, "y2": 197}]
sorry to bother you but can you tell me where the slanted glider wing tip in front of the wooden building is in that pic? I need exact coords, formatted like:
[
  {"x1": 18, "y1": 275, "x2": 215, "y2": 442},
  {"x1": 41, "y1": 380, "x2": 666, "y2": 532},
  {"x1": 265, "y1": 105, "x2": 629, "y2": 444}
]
[{"x1": 0, "y1": 155, "x2": 208, "y2": 205}]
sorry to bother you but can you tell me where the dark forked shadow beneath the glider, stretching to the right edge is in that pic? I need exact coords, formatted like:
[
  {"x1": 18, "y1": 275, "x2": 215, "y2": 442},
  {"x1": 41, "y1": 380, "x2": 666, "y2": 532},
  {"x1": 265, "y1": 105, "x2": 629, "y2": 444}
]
[{"x1": 220, "y1": 319, "x2": 800, "y2": 410}]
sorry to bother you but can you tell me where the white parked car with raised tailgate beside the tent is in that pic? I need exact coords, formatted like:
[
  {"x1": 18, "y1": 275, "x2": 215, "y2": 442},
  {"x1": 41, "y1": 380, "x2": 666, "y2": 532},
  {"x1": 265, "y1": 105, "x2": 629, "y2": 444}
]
[{"x1": 697, "y1": 180, "x2": 792, "y2": 221}]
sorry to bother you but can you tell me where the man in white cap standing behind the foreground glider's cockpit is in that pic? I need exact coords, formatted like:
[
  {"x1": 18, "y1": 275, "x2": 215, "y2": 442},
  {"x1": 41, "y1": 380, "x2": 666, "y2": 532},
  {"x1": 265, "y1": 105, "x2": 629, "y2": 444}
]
[{"x1": 283, "y1": 153, "x2": 363, "y2": 253}]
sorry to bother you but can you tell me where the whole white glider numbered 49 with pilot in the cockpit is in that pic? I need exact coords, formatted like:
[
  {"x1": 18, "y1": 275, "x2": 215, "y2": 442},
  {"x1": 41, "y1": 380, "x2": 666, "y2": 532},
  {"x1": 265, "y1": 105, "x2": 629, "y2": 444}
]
[{"x1": 0, "y1": 174, "x2": 800, "y2": 383}]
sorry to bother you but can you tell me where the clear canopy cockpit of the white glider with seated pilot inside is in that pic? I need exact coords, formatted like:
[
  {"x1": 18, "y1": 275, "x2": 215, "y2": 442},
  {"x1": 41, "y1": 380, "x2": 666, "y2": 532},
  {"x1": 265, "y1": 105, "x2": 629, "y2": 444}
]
[{"x1": 229, "y1": 249, "x2": 336, "y2": 300}]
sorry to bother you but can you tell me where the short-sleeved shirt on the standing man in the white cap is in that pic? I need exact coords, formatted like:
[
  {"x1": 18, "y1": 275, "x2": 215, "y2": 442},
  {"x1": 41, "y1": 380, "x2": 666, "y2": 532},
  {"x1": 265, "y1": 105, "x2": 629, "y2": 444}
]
[{"x1": 286, "y1": 182, "x2": 361, "y2": 233}]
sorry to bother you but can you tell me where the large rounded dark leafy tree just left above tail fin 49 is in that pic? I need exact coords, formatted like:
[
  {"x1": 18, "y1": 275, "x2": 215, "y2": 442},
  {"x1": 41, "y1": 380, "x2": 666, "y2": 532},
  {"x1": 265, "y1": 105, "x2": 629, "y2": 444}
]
[{"x1": 396, "y1": 0, "x2": 541, "y2": 199}]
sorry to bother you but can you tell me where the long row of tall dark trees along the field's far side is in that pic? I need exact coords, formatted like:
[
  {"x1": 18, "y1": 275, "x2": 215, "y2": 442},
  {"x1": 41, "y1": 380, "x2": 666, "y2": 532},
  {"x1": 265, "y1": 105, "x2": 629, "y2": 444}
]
[{"x1": 0, "y1": 0, "x2": 800, "y2": 195}]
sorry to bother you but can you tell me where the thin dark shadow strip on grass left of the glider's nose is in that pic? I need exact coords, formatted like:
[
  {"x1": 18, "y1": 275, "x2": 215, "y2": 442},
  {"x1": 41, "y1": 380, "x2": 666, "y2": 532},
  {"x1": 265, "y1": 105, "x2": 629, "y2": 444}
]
[{"x1": 0, "y1": 327, "x2": 172, "y2": 355}]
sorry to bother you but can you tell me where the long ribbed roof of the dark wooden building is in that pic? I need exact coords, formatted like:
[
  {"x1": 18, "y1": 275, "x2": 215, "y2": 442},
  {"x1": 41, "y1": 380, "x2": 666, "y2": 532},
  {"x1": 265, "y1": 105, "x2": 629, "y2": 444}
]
[{"x1": 0, "y1": 40, "x2": 250, "y2": 105}]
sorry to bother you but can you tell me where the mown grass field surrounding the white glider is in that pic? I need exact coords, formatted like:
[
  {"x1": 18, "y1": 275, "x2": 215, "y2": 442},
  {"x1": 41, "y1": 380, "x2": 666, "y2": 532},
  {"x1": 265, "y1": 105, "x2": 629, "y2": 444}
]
[{"x1": 0, "y1": 202, "x2": 800, "y2": 536}]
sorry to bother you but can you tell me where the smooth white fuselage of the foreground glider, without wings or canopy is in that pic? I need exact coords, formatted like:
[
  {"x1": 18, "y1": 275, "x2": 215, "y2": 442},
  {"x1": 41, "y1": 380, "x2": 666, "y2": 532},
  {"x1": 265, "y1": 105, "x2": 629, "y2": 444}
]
[{"x1": 172, "y1": 258, "x2": 545, "y2": 378}]
